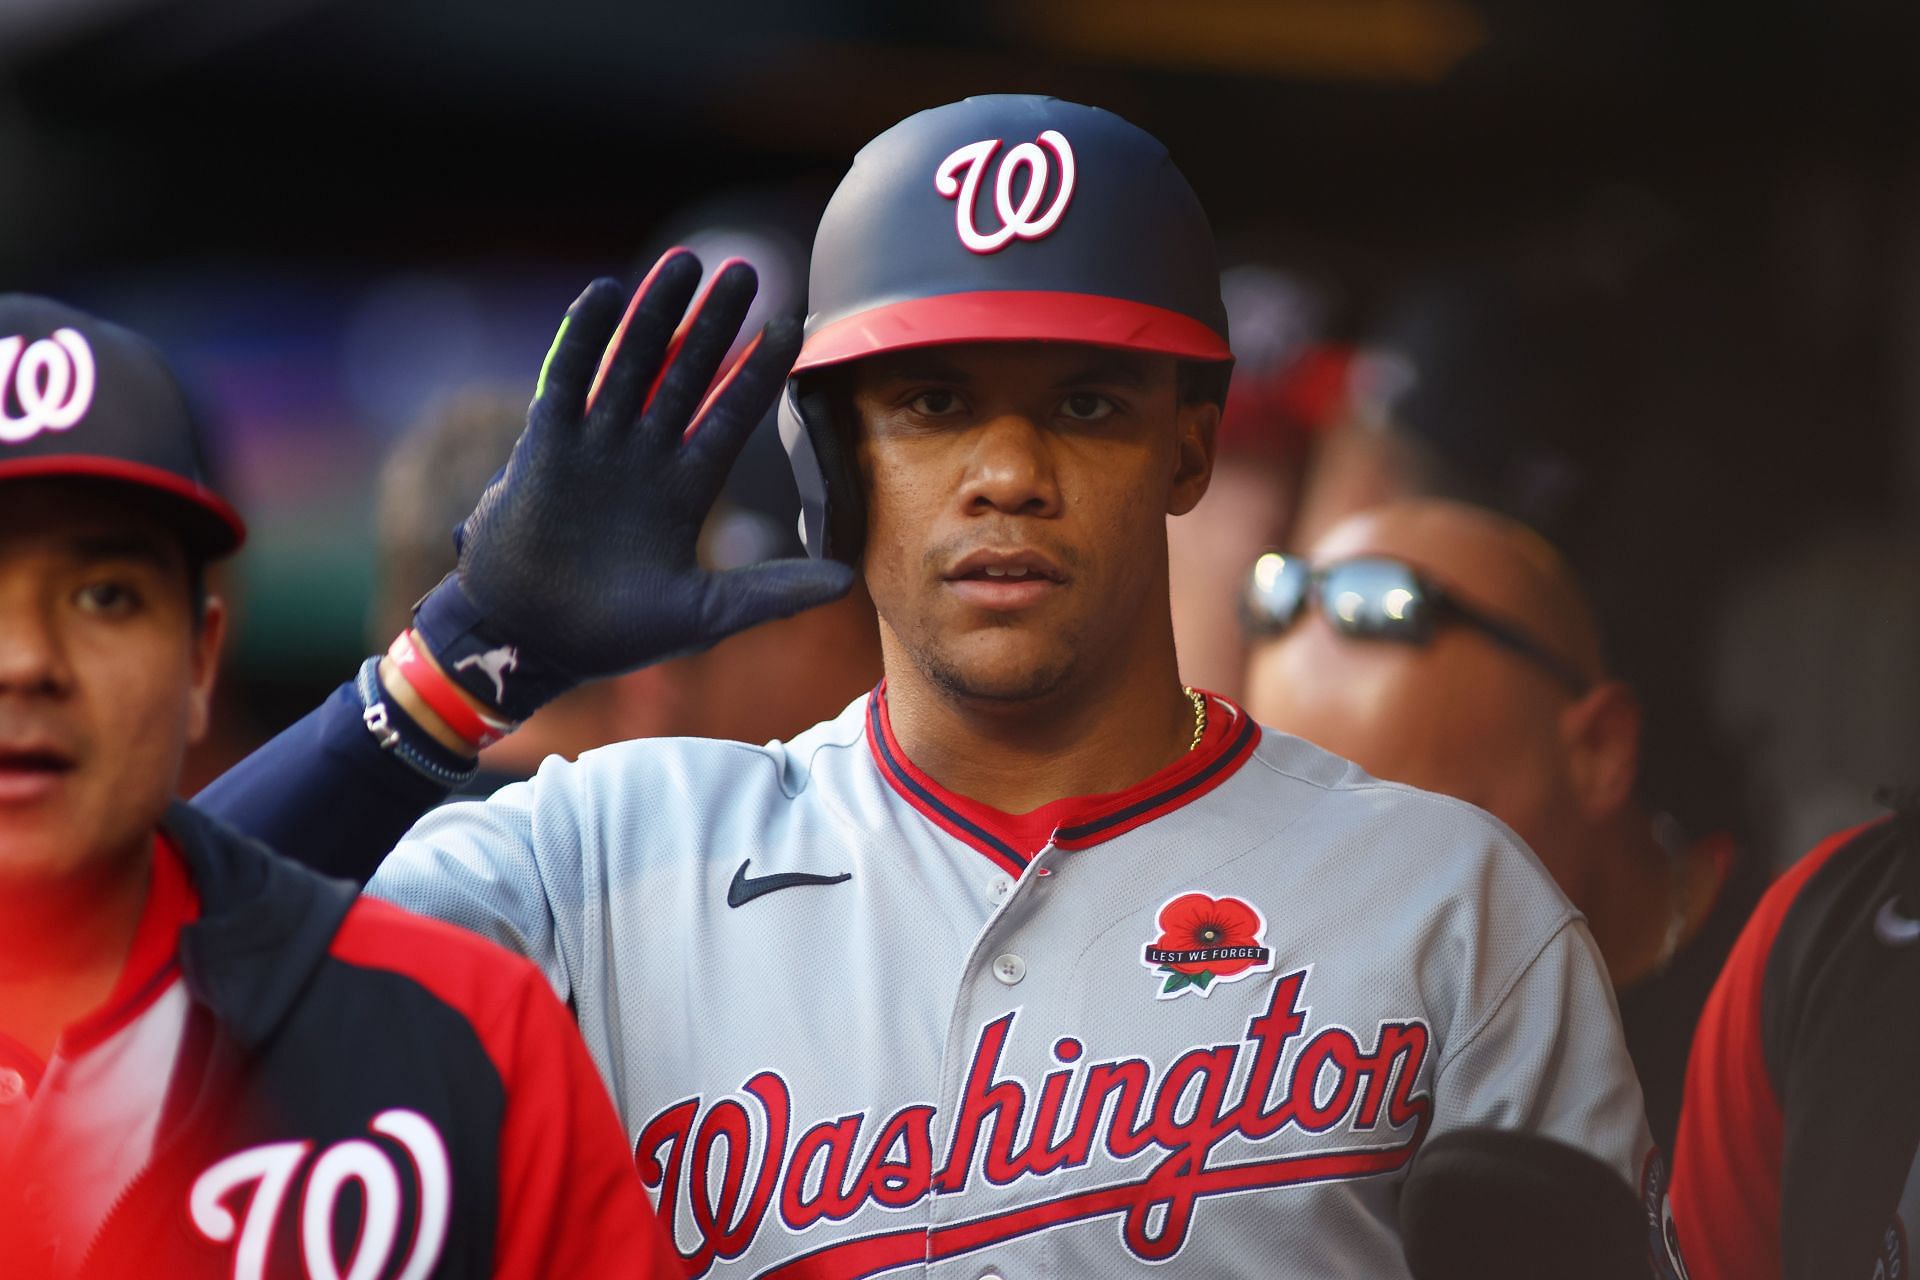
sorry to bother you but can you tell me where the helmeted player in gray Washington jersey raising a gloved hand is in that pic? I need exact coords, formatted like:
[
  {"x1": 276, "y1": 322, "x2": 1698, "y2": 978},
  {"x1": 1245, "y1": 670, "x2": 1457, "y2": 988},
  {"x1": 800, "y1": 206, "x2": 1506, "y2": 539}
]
[{"x1": 191, "y1": 96, "x2": 1651, "y2": 1280}]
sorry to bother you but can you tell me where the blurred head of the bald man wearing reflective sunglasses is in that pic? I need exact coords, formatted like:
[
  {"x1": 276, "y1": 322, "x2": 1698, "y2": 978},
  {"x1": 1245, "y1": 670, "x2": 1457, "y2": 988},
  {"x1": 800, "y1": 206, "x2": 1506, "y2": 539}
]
[{"x1": 1246, "y1": 505, "x2": 1597, "y2": 873}]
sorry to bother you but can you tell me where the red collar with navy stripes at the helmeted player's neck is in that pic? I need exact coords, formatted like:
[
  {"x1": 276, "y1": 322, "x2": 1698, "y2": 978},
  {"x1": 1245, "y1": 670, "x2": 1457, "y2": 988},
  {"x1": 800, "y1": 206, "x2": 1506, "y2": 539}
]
[{"x1": 866, "y1": 679, "x2": 1260, "y2": 875}]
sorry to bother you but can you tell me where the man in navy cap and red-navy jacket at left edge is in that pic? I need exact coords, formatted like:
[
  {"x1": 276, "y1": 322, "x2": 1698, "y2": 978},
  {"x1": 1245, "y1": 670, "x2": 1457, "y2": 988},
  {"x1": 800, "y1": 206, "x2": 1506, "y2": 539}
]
[{"x1": 0, "y1": 294, "x2": 676, "y2": 1280}]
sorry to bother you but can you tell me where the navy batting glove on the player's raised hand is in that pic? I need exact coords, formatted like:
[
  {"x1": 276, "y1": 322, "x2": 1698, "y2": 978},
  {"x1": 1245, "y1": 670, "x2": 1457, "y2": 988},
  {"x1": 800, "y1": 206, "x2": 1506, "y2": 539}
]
[{"x1": 413, "y1": 249, "x2": 852, "y2": 720}]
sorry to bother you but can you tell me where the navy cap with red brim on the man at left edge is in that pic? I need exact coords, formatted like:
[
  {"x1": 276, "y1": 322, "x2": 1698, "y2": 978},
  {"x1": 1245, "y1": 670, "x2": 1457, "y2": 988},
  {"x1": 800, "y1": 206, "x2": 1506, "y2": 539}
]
[{"x1": 0, "y1": 294, "x2": 246, "y2": 557}]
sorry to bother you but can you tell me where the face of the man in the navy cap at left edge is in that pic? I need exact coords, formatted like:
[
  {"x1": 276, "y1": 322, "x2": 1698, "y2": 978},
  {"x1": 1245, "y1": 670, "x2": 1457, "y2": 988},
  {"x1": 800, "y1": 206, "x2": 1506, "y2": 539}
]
[{"x1": 0, "y1": 480, "x2": 221, "y2": 887}]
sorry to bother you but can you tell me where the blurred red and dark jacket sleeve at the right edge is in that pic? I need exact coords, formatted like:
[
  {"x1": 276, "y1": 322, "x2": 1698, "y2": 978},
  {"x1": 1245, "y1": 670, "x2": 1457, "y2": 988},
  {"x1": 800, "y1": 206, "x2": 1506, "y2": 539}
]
[{"x1": 1672, "y1": 812, "x2": 1920, "y2": 1280}]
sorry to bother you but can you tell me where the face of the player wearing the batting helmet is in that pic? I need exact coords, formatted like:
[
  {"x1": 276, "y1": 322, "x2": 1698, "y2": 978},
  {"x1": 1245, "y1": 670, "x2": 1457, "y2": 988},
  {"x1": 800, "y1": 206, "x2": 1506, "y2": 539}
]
[{"x1": 852, "y1": 344, "x2": 1217, "y2": 700}]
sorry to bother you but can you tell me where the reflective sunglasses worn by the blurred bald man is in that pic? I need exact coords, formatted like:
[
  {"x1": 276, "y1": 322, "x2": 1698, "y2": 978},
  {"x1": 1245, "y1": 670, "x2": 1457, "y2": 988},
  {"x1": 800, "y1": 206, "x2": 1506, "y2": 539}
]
[{"x1": 1242, "y1": 551, "x2": 1592, "y2": 697}]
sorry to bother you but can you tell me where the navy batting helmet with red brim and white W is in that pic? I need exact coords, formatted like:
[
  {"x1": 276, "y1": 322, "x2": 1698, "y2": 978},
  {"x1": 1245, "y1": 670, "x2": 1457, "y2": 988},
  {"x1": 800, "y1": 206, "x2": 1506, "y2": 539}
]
[{"x1": 780, "y1": 94, "x2": 1233, "y2": 562}]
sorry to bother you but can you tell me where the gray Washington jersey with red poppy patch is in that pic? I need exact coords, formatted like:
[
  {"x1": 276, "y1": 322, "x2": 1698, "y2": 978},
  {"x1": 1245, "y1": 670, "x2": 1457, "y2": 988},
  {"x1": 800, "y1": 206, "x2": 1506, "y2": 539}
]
[{"x1": 372, "y1": 695, "x2": 1651, "y2": 1280}]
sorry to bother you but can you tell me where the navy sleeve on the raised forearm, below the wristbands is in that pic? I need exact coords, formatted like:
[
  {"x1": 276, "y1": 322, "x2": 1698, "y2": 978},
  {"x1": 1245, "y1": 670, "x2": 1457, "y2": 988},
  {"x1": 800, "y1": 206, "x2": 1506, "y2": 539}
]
[{"x1": 194, "y1": 681, "x2": 449, "y2": 885}]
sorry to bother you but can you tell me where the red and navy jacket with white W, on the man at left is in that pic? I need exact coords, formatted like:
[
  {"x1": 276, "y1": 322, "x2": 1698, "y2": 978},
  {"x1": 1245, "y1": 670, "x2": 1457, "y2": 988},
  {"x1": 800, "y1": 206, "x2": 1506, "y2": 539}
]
[{"x1": 10, "y1": 804, "x2": 678, "y2": 1280}]
